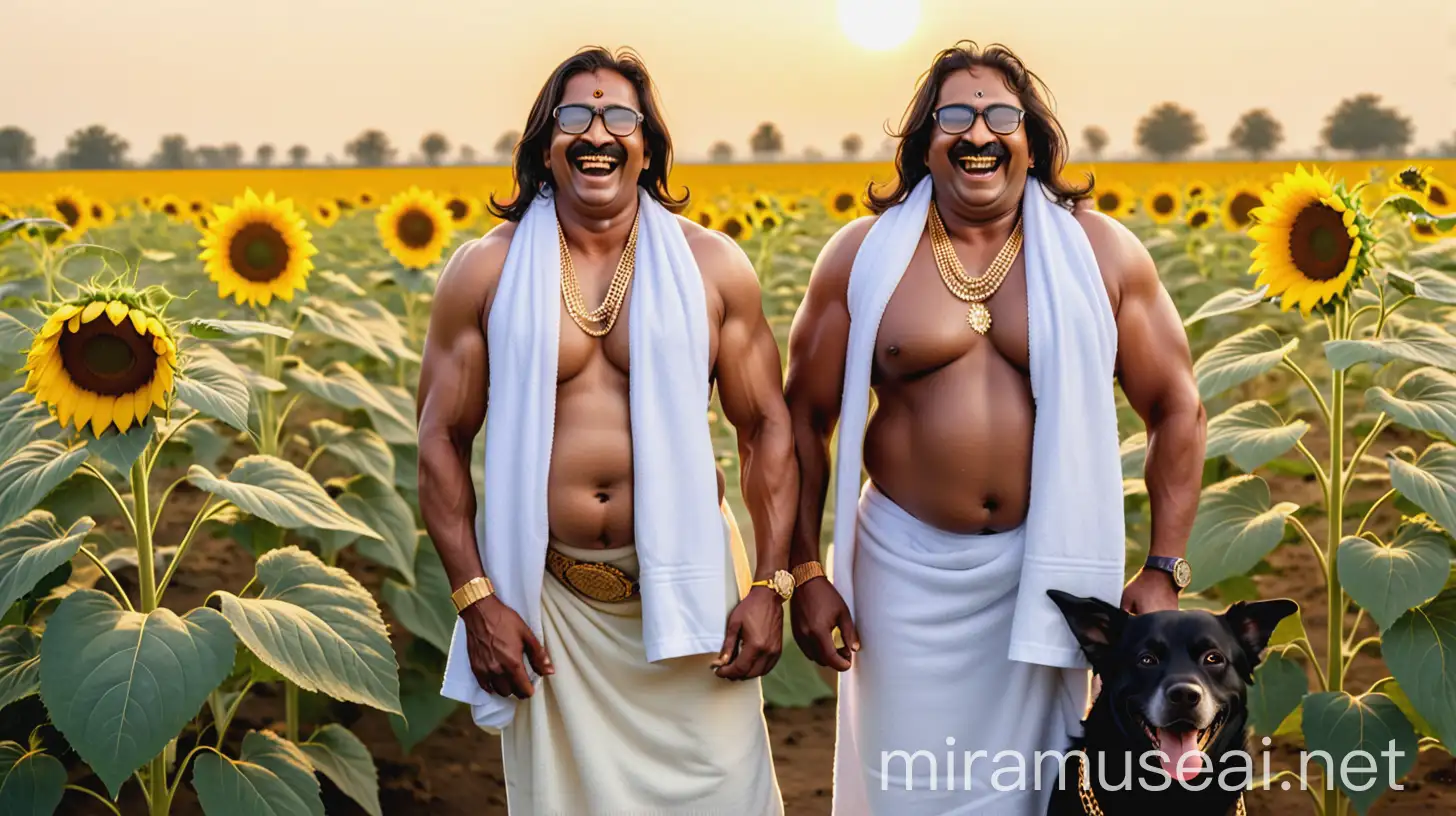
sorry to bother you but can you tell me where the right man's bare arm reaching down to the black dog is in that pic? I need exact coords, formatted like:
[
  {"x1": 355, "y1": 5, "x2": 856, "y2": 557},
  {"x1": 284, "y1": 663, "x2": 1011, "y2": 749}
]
[{"x1": 1077, "y1": 211, "x2": 1207, "y2": 612}]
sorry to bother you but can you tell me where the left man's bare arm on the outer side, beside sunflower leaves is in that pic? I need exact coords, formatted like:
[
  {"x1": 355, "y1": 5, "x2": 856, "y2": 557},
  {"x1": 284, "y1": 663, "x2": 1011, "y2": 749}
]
[{"x1": 416, "y1": 230, "x2": 550, "y2": 698}]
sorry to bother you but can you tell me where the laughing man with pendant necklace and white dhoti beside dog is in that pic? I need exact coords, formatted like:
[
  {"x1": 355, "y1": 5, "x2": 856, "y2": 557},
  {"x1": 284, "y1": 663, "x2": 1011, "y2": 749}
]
[{"x1": 786, "y1": 44, "x2": 1204, "y2": 816}]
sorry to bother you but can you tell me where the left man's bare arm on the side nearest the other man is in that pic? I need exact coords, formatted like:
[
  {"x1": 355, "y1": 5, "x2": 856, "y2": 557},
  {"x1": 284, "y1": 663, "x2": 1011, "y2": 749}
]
[{"x1": 695, "y1": 230, "x2": 798, "y2": 680}]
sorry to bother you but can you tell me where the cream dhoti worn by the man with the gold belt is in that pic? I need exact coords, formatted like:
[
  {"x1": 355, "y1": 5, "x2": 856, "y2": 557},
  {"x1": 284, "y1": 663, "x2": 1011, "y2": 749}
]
[{"x1": 501, "y1": 509, "x2": 783, "y2": 816}]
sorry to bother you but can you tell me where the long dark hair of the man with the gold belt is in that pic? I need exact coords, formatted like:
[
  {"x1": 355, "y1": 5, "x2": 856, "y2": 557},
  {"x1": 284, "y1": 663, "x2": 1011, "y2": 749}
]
[{"x1": 486, "y1": 45, "x2": 687, "y2": 221}]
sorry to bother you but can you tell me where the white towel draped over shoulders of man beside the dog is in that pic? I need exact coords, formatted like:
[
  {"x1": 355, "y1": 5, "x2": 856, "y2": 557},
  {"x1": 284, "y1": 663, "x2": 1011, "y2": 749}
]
[{"x1": 833, "y1": 178, "x2": 1125, "y2": 667}]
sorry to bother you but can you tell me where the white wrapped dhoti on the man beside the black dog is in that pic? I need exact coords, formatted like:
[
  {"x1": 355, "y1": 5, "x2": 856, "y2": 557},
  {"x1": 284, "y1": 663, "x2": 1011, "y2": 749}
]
[{"x1": 834, "y1": 484, "x2": 1089, "y2": 816}]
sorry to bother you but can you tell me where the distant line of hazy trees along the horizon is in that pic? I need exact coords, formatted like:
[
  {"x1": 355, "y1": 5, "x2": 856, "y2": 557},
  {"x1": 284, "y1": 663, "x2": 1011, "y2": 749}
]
[{"x1": 0, "y1": 93, "x2": 1456, "y2": 170}]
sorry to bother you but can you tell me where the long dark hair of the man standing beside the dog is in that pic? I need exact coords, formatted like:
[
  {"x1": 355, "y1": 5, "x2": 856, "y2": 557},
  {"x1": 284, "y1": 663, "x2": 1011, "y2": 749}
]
[{"x1": 865, "y1": 39, "x2": 1093, "y2": 214}]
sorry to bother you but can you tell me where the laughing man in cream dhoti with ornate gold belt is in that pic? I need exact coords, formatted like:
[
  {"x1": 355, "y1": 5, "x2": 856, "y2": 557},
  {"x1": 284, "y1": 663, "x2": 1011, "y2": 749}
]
[{"x1": 419, "y1": 48, "x2": 798, "y2": 816}]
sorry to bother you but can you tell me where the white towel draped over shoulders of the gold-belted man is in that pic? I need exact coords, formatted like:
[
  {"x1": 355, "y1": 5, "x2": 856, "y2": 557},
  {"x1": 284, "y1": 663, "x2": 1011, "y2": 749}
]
[{"x1": 441, "y1": 191, "x2": 728, "y2": 729}]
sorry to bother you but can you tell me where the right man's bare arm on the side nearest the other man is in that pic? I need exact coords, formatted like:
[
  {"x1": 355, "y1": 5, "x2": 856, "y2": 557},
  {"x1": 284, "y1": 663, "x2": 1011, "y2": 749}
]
[{"x1": 785, "y1": 219, "x2": 874, "y2": 672}]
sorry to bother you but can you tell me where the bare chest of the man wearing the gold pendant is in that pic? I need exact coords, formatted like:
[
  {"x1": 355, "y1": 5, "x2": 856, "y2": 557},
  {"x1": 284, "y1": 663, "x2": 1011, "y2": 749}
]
[{"x1": 874, "y1": 240, "x2": 1031, "y2": 383}]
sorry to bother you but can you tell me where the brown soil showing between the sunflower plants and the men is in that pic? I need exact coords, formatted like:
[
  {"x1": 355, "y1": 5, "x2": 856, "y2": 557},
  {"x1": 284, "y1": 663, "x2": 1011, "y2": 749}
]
[{"x1": 28, "y1": 434, "x2": 1456, "y2": 816}]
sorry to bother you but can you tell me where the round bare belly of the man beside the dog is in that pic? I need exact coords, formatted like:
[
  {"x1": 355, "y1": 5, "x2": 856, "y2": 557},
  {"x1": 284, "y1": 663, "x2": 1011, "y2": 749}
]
[{"x1": 865, "y1": 354, "x2": 1035, "y2": 533}]
